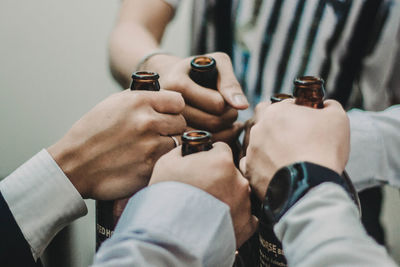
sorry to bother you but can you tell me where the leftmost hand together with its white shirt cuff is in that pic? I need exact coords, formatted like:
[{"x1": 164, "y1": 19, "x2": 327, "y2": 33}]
[{"x1": 0, "y1": 90, "x2": 186, "y2": 260}]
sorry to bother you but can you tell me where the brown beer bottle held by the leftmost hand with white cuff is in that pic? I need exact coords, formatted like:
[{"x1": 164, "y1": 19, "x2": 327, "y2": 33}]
[{"x1": 96, "y1": 71, "x2": 160, "y2": 251}]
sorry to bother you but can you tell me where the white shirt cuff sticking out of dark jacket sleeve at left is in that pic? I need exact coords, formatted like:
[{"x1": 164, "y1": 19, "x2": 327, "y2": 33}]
[{"x1": 0, "y1": 149, "x2": 87, "y2": 260}]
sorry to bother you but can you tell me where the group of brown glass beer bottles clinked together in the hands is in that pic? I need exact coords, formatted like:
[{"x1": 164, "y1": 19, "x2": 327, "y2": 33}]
[{"x1": 96, "y1": 56, "x2": 360, "y2": 267}]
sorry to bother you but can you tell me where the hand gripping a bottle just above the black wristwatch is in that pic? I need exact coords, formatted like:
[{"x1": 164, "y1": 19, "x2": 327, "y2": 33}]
[{"x1": 240, "y1": 100, "x2": 350, "y2": 199}]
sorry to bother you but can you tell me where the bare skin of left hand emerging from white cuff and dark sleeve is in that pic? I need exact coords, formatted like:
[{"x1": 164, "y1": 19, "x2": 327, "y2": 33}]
[{"x1": 48, "y1": 90, "x2": 186, "y2": 200}]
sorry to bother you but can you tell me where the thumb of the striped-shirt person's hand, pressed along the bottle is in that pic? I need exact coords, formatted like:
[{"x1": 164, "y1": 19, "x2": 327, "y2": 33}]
[{"x1": 209, "y1": 53, "x2": 249, "y2": 109}]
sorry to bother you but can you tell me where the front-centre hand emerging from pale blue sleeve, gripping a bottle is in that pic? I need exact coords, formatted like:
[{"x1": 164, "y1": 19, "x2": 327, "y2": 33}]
[{"x1": 149, "y1": 142, "x2": 257, "y2": 247}]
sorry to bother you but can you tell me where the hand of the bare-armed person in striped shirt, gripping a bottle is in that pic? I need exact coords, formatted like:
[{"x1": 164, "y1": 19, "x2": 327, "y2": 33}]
[{"x1": 143, "y1": 53, "x2": 249, "y2": 143}]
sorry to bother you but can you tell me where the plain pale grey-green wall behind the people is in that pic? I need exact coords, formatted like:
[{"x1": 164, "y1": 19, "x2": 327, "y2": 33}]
[{"x1": 0, "y1": 0, "x2": 400, "y2": 267}]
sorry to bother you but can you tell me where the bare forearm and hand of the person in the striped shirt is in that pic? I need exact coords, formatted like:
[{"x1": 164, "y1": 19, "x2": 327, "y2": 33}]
[{"x1": 109, "y1": 0, "x2": 249, "y2": 143}]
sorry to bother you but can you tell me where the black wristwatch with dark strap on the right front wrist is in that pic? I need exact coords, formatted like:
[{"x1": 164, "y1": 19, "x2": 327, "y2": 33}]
[{"x1": 262, "y1": 162, "x2": 359, "y2": 225}]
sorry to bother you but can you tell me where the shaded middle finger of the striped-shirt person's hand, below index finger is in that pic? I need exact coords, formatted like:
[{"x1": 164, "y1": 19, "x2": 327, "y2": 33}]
[{"x1": 183, "y1": 105, "x2": 238, "y2": 133}]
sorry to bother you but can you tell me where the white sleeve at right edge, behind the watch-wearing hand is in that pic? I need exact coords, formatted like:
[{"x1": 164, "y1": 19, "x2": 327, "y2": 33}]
[{"x1": 346, "y1": 105, "x2": 400, "y2": 191}]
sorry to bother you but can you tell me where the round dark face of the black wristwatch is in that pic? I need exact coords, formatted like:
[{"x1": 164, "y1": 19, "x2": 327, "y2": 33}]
[{"x1": 266, "y1": 168, "x2": 291, "y2": 213}]
